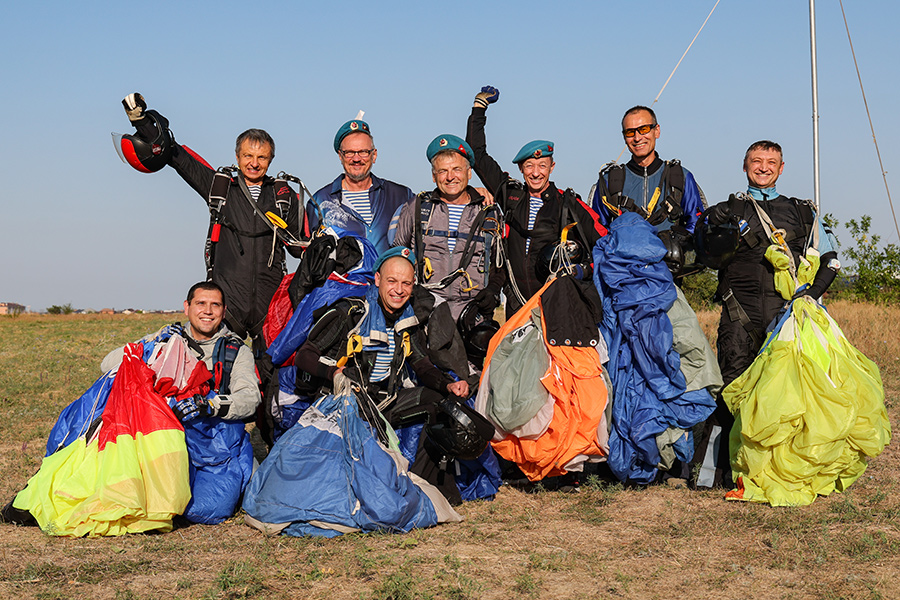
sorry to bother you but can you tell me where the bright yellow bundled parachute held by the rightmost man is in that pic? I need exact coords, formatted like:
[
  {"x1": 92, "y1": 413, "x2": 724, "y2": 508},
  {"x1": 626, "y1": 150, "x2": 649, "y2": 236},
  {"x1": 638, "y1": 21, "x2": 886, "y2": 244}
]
[{"x1": 722, "y1": 206, "x2": 891, "y2": 506}]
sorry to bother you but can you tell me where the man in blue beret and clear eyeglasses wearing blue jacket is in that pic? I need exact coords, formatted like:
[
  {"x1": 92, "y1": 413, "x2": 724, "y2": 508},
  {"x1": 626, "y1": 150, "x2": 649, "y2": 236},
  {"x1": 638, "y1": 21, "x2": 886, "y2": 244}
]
[{"x1": 304, "y1": 119, "x2": 414, "y2": 252}]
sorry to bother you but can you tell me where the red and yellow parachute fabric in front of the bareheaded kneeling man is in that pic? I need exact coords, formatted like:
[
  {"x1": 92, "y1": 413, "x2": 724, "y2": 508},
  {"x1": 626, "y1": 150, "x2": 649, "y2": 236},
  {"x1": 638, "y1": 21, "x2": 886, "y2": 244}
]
[{"x1": 13, "y1": 344, "x2": 191, "y2": 537}]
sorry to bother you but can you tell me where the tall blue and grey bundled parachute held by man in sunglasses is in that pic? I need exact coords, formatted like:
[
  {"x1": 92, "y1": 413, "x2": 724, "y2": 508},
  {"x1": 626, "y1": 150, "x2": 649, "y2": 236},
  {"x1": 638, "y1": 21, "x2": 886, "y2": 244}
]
[{"x1": 593, "y1": 212, "x2": 722, "y2": 484}]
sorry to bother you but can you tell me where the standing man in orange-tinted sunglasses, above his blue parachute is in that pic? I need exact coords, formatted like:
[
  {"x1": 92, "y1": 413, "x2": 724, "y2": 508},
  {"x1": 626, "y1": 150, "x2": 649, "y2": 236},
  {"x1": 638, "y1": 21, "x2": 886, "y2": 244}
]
[{"x1": 590, "y1": 106, "x2": 706, "y2": 277}]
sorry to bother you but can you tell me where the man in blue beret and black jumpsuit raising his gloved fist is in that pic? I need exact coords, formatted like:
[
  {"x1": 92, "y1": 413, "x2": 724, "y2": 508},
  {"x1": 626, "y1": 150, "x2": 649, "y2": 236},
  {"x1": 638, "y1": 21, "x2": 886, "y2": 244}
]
[{"x1": 466, "y1": 86, "x2": 606, "y2": 316}]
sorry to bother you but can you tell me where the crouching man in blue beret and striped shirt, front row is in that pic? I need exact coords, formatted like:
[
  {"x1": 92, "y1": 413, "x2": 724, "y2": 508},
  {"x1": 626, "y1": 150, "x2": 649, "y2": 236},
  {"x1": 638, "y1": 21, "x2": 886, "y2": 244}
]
[{"x1": 294, "y1": 247, "x2": 493, "y2": 504}]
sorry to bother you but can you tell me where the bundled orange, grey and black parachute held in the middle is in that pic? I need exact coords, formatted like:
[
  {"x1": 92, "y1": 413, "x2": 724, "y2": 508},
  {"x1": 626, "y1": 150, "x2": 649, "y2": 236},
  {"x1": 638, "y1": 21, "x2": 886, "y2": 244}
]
[{"x1": 475, "y1": 275, "x2": 608, "y2": 482}]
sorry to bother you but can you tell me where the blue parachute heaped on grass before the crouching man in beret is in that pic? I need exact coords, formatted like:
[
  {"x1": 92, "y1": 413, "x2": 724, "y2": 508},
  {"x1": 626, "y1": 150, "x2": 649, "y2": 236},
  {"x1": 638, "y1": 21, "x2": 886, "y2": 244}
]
[{"x1": 243, "y1": 376, "x2": 462, "y2": 537}]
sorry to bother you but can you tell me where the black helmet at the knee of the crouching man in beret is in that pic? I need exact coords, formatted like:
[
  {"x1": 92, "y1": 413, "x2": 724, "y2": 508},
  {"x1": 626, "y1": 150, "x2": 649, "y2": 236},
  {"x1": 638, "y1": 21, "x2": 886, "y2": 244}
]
[{"x1": 425, "y1": 398, "x2": 494, "y2": 460}]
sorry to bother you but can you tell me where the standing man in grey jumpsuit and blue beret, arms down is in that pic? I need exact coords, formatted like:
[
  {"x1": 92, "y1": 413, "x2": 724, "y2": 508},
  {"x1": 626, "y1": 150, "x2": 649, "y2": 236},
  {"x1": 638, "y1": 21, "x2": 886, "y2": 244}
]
[{"x1": 394, "y1": 134, "x2": 504, "y2": 320}]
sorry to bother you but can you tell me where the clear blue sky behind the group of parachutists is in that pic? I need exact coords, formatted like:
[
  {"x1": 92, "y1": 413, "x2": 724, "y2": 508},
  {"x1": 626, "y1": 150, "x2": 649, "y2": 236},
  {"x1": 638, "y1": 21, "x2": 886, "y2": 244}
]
[{"x1": 0, "y1": 0, "x2": 900, "y2": 310}]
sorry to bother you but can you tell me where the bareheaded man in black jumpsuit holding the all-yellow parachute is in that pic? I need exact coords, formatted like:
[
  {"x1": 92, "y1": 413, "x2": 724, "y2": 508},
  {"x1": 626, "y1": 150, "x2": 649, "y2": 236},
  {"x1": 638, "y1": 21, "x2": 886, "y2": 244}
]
[{"x1": 695, "y1": 140, "x2": 840, "y2": 488}]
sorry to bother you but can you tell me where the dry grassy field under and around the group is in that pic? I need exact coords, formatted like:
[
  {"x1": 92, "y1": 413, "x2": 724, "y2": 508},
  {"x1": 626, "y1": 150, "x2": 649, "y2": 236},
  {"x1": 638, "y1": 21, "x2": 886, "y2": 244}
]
[{"x1": 0, "y1": 303, "x2": 900, "y2": 600}]
